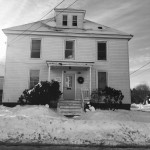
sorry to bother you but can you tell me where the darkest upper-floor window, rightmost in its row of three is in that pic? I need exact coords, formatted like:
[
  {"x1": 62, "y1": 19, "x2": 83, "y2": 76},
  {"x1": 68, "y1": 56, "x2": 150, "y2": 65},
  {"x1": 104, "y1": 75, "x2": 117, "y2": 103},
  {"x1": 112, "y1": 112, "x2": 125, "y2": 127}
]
[{"x1": 97, "y1": 42, "x2": 107, "y2": 60}]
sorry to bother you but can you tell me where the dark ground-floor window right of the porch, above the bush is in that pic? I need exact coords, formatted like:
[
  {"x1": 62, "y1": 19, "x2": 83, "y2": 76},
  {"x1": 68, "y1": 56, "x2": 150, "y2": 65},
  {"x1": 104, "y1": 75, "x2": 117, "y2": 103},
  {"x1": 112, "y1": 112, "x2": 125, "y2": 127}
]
[{"x1": 98, "y1": 72, "x2": 107, "y2": 89}]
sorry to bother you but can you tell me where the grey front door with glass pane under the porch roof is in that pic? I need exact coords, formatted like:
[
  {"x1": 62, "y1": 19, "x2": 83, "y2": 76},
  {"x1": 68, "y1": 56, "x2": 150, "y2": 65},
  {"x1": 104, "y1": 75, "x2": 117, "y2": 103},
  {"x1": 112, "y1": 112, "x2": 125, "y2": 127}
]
[{"x1": 63, "y1": 73, "x2": 75, "y2": 100}]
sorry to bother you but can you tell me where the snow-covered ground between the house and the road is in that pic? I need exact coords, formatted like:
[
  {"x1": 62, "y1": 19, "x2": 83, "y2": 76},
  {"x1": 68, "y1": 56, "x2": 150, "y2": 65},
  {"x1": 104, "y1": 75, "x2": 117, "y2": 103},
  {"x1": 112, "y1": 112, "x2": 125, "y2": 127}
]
[{"x1": 0, "y1": 106, "x2": 150, "y2": 145}]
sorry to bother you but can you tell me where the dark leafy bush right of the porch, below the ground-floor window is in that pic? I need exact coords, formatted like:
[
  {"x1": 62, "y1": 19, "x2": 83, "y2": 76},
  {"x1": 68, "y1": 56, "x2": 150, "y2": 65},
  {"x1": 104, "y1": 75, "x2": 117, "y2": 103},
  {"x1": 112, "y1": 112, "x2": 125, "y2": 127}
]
[{"x1": 91, "y1": 87, "x2": 124, "y2": 110}]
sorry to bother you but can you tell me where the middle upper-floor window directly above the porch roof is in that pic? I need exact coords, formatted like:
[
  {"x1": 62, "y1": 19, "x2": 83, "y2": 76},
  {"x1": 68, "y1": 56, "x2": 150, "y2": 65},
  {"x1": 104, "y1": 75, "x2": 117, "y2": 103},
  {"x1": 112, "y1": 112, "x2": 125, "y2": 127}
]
[{"x1": 65, "y1": 41, "x2": 75, "y2": 59}]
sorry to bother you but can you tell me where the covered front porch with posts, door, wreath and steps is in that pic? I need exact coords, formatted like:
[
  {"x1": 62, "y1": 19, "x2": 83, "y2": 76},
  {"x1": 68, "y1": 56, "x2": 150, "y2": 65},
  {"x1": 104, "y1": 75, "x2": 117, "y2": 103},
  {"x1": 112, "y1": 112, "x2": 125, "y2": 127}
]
[{"x1": 47, "y1": 61, "x2": 94, "y2": 115}]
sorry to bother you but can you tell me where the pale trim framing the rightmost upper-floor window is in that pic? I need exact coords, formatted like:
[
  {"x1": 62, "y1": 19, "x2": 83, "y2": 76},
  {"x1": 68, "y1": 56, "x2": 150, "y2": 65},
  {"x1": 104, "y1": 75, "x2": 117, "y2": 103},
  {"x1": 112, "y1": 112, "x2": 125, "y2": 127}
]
[{"x1": 96, "y1": 40, "x2": 108, "y2": 62}]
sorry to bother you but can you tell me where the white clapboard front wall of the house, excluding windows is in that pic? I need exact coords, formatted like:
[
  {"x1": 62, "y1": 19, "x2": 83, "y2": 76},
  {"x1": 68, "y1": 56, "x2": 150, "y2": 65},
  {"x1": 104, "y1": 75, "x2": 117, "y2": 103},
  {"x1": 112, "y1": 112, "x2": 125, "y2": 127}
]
[{"x1": 3, "y1": 35, "x2": 130, "y2": 104}]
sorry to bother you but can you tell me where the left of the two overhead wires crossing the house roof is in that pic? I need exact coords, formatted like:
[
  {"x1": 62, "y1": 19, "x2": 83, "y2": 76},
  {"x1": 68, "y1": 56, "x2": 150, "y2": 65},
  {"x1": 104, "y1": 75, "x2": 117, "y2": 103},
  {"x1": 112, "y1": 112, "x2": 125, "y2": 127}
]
[{"x1": 8, "y1": 0, "x2": 65, "y2": 44}]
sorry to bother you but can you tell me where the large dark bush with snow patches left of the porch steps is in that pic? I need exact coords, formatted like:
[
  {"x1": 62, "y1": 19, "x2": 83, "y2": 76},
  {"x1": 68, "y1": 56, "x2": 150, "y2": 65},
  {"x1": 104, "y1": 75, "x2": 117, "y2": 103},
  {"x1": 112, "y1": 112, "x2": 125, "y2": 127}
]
[{"x1": 18, "y1": 80, "x2": 62, "y2": 107}]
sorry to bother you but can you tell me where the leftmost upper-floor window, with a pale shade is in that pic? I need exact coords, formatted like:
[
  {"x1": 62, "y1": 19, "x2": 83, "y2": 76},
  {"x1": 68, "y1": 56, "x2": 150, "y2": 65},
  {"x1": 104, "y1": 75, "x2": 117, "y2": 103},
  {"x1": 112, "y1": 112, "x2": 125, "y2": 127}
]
[{"x1": 31, "y1": 39, "x2": 41, "y2": 58}]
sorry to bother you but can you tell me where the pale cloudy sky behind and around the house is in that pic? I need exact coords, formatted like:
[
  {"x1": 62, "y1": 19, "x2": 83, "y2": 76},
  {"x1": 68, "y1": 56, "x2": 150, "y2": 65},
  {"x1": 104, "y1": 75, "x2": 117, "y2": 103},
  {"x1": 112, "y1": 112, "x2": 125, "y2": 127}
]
[{"x1": 0, "y1": 0, "x2": 150, "y2": 88}]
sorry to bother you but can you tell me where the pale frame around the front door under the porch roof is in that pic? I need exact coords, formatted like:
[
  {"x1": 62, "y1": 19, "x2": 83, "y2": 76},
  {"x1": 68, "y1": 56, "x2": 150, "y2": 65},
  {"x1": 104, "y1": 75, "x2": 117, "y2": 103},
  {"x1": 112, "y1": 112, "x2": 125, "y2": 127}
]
[{"x1": 62, "y1": 70, "x2": 77, "y2": 100}]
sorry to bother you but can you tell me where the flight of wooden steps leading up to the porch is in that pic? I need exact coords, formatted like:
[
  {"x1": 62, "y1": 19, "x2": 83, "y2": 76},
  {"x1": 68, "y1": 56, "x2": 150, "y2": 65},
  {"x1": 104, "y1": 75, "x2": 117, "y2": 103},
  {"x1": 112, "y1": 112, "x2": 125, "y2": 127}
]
[{"x1": 58, "y1": 100, "x2": 82, "y2": 116}]
